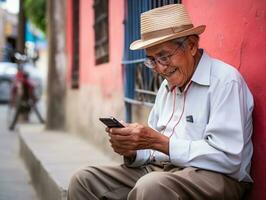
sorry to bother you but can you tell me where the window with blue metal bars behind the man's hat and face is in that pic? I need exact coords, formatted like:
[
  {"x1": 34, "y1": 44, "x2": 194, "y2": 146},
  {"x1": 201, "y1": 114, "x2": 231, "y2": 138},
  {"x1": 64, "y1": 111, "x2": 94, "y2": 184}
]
[{"x1": 123, "y1": 0, "x2": 181, "y2": 122}]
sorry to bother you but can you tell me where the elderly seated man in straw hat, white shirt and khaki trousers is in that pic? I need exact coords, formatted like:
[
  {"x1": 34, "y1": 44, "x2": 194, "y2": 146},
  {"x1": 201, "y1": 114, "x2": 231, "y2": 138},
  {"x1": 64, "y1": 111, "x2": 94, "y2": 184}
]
[{"x1": 68, "y1": 4, "x2": 253, "y2": 200}]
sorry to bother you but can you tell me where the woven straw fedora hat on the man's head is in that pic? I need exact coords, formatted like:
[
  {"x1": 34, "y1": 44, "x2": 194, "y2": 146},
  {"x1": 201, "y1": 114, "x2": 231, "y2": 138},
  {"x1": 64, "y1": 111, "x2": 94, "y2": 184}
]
[{"x1": 130, "y1": 4, "x2": 206, "y2": 50}]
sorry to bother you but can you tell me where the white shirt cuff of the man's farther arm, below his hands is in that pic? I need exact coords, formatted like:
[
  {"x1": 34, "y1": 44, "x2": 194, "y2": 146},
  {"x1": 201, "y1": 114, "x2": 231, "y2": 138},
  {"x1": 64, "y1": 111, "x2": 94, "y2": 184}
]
[{"x1": 124, "y1": 149, "x2": 150, "y2": 167}]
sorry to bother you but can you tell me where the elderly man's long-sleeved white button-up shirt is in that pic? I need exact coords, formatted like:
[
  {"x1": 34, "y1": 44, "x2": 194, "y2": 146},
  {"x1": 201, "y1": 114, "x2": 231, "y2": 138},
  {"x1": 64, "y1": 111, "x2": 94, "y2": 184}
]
[{"x1": 131, "y1": 52, "x2": 253, "y2": 182}]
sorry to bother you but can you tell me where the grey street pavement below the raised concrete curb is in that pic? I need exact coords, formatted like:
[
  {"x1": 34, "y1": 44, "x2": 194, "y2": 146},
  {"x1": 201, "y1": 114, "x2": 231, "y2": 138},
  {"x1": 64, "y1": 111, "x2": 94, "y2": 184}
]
[{"x1": 0, "y1": 104, "x2": 39, "y2": 200}]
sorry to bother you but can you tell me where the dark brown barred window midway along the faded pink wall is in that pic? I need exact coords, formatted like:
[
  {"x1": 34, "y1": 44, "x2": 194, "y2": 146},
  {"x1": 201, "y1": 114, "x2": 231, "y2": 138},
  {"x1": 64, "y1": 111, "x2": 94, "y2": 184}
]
[{"x1": 93, "y1": 0, "x2": 109, "y2": 65}]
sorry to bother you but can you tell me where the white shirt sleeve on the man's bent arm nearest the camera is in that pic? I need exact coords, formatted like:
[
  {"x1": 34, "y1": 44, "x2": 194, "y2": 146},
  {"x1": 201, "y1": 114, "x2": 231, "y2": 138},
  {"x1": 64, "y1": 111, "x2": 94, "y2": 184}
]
[{"x1": 169, "y1": 81, "x2": 250, "y2": 177}]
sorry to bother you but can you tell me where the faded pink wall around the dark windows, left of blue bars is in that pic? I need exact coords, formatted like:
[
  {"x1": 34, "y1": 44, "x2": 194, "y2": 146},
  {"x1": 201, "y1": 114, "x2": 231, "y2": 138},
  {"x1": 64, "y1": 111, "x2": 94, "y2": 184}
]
[{"x1": 66, "y1": 0, "x2": 124, "y2": 96}]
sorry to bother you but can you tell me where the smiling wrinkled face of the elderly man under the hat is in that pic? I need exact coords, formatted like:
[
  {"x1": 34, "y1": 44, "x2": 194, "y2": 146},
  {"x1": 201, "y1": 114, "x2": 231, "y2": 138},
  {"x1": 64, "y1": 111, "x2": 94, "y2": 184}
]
[{"x1": 146, "y1": 39, "x2": 197, "y2": 88}]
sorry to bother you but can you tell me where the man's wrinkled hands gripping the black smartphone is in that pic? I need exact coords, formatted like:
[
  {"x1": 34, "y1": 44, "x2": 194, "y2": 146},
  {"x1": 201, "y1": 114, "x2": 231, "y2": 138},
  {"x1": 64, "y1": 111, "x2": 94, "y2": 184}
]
[{"x1": 106, "y1": 123, "x2": 169, "y2": 157}]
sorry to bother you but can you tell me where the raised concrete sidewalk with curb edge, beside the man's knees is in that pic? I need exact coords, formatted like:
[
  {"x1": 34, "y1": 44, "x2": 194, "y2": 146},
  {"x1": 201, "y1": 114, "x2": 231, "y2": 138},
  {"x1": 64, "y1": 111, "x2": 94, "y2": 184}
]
[{"x1": 19, "y1": 125, "x2": 119, "y2": 200}]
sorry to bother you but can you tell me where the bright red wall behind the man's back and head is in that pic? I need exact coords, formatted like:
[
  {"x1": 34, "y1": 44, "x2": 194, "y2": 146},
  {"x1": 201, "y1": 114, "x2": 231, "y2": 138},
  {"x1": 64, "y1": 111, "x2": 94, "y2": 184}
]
[{"x1": 182, "y1": 0, "x2": 266, "y2": 200}]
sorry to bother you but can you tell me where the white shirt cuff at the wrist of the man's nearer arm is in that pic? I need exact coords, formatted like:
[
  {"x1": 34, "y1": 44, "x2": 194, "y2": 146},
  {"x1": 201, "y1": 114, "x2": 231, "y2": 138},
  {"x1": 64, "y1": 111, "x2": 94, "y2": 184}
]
[{"x1": 169, "y1": 137, "x2": 190, "y2": 166}]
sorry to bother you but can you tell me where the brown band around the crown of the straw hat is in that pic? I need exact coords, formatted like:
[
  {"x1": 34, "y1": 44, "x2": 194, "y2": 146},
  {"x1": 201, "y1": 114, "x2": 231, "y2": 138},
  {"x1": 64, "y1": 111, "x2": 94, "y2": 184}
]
[{"x1": 141, "y1": 24, "x2": 193, "y2": 40}]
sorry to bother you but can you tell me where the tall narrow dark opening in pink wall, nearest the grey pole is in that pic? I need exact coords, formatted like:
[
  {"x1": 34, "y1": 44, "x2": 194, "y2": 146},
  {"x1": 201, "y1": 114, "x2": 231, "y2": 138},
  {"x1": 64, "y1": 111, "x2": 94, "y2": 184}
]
[{"x1": 71, "y1": 0, "x2": 79, "y2": 88}]
